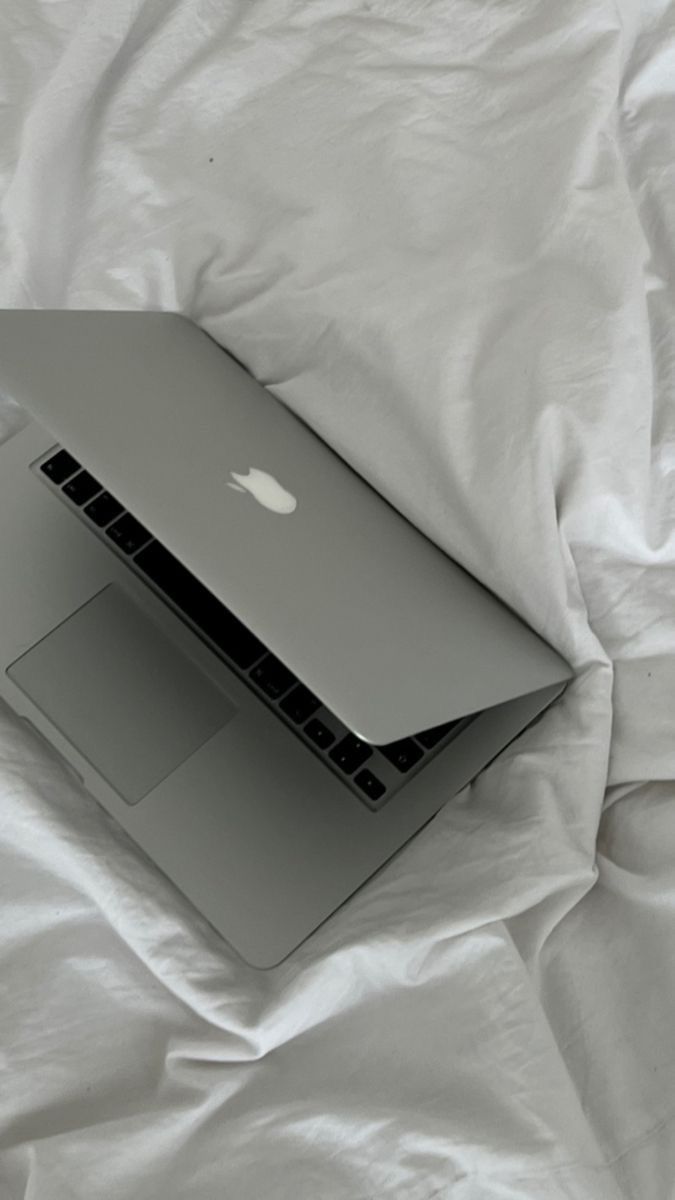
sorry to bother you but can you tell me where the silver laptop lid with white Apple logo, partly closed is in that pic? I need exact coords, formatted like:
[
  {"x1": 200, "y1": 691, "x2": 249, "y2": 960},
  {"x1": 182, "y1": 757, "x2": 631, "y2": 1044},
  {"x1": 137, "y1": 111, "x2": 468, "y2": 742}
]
[{"x1": 0, "y1": 310, "x2": 571, "y2": 743}]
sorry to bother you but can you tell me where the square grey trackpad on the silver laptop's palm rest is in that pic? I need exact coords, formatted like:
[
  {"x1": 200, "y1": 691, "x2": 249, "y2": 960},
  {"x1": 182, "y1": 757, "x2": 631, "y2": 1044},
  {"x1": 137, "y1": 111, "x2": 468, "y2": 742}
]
[{"x1": 7, "y1": 584, "x2": 235, "y2": 804}]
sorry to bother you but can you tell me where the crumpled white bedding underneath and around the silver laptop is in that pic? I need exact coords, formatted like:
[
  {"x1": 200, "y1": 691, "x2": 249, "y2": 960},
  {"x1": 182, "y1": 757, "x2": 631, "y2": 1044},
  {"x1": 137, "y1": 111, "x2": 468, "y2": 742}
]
[{"x1": 0, "y1": 0, "x2": 675, "y2": 1200}]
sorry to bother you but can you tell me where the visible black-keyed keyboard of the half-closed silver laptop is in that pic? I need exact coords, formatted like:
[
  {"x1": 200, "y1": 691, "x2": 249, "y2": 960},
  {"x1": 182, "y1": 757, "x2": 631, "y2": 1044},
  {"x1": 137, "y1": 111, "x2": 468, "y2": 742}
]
[{"x1": 34, "y1": 449, "x2": 473, "y2": 811}]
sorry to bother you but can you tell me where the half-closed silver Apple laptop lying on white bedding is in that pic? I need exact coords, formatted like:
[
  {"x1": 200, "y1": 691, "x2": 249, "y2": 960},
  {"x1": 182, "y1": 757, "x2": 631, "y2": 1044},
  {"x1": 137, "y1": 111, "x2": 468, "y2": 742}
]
[{"x1": 0, "y1": 311, "x2": 571, "y2": 967}]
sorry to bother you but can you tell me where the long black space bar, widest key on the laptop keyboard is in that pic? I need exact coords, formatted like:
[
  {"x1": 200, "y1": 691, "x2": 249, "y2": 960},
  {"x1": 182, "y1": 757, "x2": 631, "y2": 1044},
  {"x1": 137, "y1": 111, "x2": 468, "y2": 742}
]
[{"x1": 133, "y1": 541, "x2": 265, "y2": 670}]
